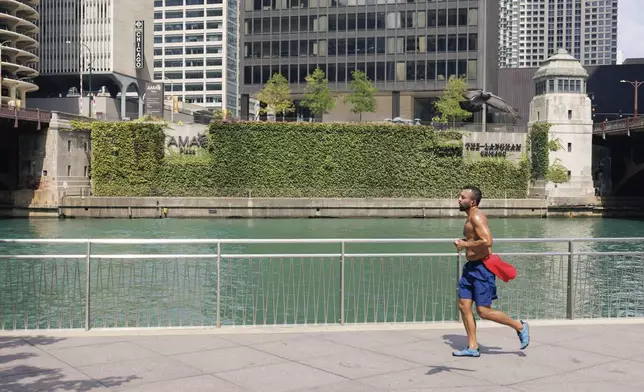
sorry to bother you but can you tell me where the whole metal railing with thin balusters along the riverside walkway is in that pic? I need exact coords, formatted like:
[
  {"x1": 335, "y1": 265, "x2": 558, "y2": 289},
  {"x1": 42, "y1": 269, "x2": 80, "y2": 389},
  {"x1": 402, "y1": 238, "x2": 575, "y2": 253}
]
[{"x1": 0, "y1": 238, "x2": 644, "y2": 330}]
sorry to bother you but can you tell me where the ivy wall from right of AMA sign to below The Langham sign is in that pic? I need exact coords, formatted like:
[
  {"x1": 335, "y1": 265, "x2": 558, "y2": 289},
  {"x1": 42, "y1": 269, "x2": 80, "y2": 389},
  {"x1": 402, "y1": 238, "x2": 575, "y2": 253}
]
[{"x1": 205, "y1": 122, "x2": 529, "y2": 198}]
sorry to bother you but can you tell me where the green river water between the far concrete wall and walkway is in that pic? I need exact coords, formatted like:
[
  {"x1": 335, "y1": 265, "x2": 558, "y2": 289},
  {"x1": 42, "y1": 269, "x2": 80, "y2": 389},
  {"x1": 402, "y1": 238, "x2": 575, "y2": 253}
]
[{"x1": 0, "y1": 218, "x2": 644, "y2": 329}]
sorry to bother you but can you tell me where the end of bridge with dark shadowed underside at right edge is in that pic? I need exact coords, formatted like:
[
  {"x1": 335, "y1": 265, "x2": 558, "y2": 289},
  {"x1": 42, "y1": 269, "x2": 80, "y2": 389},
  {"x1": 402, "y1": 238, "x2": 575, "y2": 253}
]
[{"x1": 593, "y1": 117, "x2": 644, "y2": 197}]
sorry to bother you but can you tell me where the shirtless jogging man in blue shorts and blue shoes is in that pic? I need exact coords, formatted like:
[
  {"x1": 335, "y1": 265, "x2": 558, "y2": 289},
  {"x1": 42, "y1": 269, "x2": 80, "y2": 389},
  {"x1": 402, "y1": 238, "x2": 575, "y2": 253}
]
[{"x1": 453, "y1": 186, "x2": 530, "y2": 357}]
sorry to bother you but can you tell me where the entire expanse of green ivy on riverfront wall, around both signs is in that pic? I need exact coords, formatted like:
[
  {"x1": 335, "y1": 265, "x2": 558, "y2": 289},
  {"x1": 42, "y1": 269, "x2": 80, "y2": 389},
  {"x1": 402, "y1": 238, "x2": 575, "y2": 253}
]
[{"x1": 79, "y1": 122, "x2": 530, "y2": 198}]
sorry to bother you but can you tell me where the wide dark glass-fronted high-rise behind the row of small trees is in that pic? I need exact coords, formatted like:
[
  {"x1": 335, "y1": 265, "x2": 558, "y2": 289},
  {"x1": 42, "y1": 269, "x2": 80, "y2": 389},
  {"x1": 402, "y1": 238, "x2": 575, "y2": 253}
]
[{"x1": 240, "y1": 0, "x2": 499, "y2": 121}]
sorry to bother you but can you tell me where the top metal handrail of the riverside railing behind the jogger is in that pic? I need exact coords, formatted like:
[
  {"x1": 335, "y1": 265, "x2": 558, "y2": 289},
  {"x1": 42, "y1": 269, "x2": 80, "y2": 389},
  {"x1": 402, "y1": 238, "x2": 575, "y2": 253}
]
[{"x1": 0, "y1": 237, "x2": 644, "y2": 245}]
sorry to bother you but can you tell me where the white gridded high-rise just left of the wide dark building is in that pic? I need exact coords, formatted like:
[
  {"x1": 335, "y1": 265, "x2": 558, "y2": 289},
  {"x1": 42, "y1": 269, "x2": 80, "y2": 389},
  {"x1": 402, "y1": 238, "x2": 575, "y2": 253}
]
[{"x1": 154, "y1": 0, "x2": 239, "y2": 116}]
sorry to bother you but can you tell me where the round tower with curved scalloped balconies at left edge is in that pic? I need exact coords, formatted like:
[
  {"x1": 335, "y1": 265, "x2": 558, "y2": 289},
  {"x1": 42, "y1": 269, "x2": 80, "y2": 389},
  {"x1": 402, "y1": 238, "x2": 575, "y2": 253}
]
[{"x1": 0, "y1": 0, "x2": 40, "y2": 106}]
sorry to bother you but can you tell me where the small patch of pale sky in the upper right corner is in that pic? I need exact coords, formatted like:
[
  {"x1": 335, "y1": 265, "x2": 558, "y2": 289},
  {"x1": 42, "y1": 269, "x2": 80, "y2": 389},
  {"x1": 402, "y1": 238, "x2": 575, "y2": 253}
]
[{"x1": 617, "y1": 0, "x2": 644, "y2": 58}]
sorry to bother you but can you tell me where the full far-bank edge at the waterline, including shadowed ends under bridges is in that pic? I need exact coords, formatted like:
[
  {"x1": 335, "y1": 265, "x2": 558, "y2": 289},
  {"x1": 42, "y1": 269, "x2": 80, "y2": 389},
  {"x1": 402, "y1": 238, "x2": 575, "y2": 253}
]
[{"x1": 10, "y1": 196, "x2": 632, "y2": 219}]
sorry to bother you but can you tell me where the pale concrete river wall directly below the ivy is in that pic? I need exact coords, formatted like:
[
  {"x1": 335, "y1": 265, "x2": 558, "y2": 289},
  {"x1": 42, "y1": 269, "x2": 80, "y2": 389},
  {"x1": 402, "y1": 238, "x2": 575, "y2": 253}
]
[{"x1": 58, "y1": 197, "x2": 548, "y2": 218}]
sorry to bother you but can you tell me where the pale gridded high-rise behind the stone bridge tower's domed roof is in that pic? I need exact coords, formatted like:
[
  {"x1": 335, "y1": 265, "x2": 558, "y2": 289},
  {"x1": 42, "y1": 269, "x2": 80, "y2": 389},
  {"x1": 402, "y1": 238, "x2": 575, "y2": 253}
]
[{"x1": 499, "y1": 0, "x2": 618, "y2": 68}]
